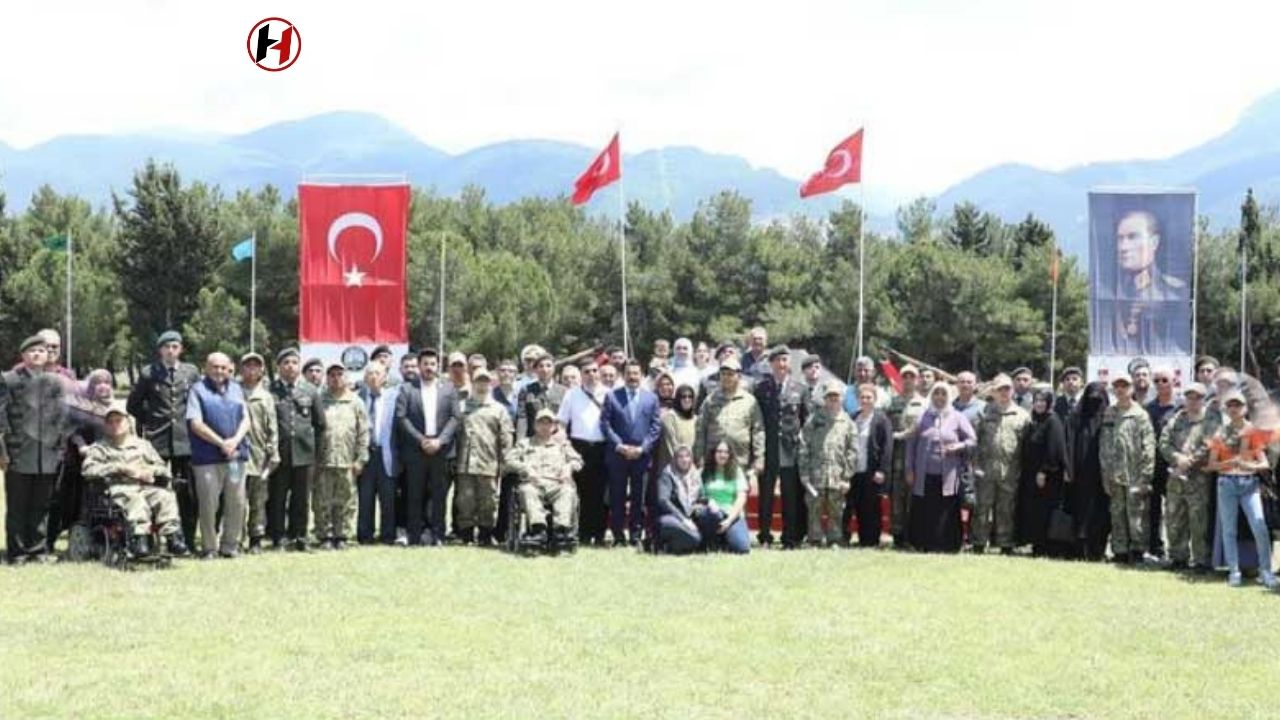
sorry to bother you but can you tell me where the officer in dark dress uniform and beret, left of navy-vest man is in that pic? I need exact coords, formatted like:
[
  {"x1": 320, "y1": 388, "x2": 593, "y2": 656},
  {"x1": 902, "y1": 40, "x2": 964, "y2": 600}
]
[{"x1": 127, "y1": 331, "x2": 200, "y2": 547}]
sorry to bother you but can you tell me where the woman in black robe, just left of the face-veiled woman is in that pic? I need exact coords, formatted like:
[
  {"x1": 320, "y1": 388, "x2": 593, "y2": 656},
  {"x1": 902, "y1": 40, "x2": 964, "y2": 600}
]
[{"x1": 1016, "y1": 389, "x2": 1070, "y2": 557}]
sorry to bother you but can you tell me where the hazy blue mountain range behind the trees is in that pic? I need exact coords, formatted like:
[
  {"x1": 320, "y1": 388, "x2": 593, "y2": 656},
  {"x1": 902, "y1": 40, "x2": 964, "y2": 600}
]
[{"x1": 0, "y1": 91, "x2": 1280, "y2": 256}]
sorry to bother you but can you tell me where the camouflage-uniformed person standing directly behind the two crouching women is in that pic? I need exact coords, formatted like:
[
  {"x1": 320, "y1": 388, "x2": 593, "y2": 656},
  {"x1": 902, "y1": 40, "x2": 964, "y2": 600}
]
[{"x1": 694, "y1": 357, "x2": 764, "y2": 482}]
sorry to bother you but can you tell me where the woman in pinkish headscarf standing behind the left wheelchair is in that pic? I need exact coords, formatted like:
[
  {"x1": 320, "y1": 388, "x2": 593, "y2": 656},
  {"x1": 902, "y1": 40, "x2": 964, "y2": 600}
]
[{"x1": 49, "y1": 370, "x2": 115, "y2": 547}]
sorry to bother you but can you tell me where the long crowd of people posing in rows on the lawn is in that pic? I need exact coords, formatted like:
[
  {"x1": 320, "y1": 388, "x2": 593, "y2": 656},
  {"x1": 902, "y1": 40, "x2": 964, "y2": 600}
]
[{"x1": 0, "y1": 328, "x2": 1280, "y2": 588}]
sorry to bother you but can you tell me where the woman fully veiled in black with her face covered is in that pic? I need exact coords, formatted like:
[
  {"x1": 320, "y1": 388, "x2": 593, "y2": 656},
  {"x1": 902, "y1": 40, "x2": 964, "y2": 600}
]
[{"x1": 1065, "y1": 382, "x2": 1111, "y2": 562}]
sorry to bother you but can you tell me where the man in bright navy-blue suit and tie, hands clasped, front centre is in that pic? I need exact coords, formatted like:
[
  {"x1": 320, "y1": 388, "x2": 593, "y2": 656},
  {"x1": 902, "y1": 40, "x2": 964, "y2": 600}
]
[{"x1": 600, "y1": 359, "x2": 662, "y2": 546}]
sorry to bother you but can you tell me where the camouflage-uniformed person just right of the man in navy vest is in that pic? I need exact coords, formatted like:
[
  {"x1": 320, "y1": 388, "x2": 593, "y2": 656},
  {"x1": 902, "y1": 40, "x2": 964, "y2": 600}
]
[{"x1": 241, "y1": 352, "x2": 280, "y2": 555}]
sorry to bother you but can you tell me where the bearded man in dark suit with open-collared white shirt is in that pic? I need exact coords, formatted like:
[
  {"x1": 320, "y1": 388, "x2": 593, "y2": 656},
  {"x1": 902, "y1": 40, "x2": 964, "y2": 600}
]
[{"x1": 396, "y1": 348, "x2": 458, "y2": 547}]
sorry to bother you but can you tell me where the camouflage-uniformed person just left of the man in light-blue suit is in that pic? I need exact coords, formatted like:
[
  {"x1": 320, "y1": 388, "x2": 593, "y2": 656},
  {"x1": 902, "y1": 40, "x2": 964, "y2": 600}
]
[{"x1": 311, "y1": 363, "x2": 369, "y2": 550}]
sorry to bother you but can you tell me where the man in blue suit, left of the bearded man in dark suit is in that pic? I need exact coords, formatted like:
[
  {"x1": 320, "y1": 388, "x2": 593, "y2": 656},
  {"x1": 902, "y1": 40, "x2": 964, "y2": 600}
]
[{"x1": 356, "y1": 363, "x2": 399, "y2": 544}]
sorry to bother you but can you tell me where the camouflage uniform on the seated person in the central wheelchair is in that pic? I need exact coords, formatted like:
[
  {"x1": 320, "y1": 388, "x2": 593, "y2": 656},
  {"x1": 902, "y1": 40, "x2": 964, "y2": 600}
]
[{"x1": 507, "y1": 436, "x2": 582, "y2": 529}]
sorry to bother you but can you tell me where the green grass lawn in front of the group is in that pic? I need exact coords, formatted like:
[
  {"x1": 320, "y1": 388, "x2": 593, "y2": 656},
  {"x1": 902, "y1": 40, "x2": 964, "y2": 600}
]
[{"x1": 0, "y1": 535, "x2": 1280, "y2": 720}]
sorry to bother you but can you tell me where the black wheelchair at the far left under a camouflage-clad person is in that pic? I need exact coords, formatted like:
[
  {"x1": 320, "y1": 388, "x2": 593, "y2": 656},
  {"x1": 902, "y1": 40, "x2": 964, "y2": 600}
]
[{"x1": 67, "y1": 479, "x2": 173, "y2": 570}]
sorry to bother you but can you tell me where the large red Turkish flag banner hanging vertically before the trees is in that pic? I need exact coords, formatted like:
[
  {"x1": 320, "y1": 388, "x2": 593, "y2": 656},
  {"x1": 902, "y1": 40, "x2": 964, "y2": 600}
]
[{"x1": 298, "y1": 184, "x2": 408, "y2": 345}]
